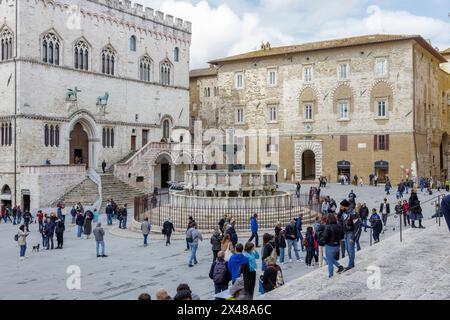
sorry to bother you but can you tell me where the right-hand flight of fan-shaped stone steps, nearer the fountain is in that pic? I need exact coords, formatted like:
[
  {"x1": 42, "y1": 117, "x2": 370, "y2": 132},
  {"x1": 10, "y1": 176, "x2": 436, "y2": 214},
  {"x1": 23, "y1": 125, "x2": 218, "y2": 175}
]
[{"x1": 100, "y1": 174, "x2": 144, "y2": 213}]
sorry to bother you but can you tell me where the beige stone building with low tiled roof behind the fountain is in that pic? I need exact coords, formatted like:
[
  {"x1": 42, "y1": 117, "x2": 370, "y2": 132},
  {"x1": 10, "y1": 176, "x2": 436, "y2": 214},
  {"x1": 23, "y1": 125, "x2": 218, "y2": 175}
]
[{"x1": 190, "y1": 35, "x2": 450, "y2": 183}]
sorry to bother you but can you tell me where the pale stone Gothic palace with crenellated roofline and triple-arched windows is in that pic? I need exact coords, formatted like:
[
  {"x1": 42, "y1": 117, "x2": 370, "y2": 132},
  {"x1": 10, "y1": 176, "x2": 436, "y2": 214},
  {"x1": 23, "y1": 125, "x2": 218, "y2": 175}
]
[{"x1": 0, "y1": 0, "x2": 191, "y2": 209}]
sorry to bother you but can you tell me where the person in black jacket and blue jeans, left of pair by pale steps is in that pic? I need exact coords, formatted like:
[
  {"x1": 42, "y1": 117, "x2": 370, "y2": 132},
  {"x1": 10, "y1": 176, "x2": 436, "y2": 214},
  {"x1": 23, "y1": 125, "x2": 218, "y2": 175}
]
[{"x1": 323, "y1": 214, "x2": 344, "y2": 278}]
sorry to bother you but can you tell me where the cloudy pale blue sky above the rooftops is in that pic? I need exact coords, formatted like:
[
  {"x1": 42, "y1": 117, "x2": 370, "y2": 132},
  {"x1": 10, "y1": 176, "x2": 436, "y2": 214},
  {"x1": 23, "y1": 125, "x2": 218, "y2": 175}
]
[{"x1": 138, "y1": 0, "x2": 450, "y2": 68}]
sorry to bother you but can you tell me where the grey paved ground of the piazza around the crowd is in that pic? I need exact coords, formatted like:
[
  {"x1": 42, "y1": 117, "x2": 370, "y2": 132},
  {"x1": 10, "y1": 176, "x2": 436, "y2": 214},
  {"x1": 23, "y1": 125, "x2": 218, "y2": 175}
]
[{"x1": 0, "y1": 184, "x2": 437, "y2": 300}]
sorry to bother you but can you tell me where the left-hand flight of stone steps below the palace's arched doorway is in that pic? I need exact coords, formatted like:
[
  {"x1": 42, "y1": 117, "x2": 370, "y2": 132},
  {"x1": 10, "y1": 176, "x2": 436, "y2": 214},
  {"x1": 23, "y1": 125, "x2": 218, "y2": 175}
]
[{"x1": 52, "y1": 178, "x2": 99, "y2": 207}]
